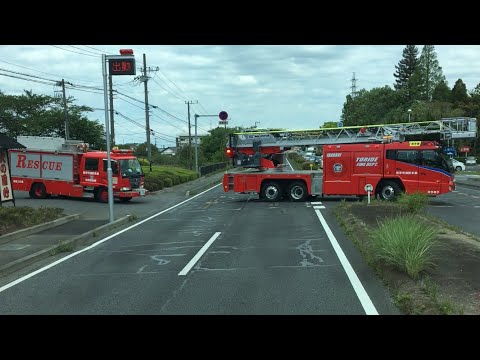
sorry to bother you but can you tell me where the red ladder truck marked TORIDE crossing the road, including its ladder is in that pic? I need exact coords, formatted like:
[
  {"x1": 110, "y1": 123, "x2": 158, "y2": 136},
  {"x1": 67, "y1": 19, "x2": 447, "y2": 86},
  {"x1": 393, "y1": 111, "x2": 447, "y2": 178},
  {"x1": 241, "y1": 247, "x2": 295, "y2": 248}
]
[{"x1": 223, "y1": 118, "x2": 477, "y2": 201}]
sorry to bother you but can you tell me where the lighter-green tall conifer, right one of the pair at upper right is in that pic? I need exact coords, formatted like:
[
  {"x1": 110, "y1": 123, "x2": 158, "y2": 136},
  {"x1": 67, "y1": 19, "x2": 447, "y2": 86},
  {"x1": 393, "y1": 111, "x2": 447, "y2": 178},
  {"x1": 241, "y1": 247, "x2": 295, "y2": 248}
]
[{"x1": 411, "y1": 45, "x2": 447, "y2": 100}]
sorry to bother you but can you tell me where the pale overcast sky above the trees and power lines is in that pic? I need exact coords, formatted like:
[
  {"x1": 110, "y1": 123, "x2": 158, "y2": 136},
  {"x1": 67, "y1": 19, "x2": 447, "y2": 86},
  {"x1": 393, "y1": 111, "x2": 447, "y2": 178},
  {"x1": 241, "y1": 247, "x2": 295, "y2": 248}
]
[{"x1": 0, "y1": 45, "x2": 480, "y2": 147}]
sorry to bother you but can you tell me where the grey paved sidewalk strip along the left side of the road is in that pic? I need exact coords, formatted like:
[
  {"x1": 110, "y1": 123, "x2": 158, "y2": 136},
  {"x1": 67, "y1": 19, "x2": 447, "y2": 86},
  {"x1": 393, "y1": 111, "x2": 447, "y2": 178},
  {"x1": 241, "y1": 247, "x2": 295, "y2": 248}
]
[{"x1": 0, "y1": 172, "x2": 223, "y2": 286}]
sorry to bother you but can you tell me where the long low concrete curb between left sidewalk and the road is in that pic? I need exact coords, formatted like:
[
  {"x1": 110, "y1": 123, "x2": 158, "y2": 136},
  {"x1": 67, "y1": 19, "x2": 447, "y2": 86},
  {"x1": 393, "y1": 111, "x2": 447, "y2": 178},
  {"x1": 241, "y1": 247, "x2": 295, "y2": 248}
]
[{"x1": 0, "y1": 215, "x2": 134, "y2": 276}]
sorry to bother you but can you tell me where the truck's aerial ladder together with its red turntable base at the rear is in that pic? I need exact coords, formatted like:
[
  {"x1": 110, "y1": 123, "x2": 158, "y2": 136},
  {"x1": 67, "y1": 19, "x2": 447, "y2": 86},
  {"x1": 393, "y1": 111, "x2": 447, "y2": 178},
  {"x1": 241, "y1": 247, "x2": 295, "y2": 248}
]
[{"x1": 227, "y1": 117, "x2": 477, "y2": 168}]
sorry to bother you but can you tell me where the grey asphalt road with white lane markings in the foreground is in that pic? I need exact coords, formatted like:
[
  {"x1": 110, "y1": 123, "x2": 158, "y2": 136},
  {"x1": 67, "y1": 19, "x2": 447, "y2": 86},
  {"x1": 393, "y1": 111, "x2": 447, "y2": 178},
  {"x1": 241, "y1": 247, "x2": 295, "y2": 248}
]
[{"x1": 0, "y1": 187, "x2": 398, "y2": 314}]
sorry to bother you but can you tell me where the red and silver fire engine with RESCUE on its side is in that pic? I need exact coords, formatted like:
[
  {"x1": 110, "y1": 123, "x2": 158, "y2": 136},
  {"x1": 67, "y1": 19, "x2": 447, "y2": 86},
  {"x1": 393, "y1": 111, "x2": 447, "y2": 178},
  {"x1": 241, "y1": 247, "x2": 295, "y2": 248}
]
[{"x1": 9, "y1": 136, "x2": 147, "y2": 202}]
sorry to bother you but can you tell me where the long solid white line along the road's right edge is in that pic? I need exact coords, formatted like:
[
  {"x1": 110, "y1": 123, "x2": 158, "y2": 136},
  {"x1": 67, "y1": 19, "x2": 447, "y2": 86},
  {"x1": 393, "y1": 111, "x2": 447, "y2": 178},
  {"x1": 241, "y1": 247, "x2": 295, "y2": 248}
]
[{"x1": 315, "y1": 210, "x2": 378, "y2": 315}]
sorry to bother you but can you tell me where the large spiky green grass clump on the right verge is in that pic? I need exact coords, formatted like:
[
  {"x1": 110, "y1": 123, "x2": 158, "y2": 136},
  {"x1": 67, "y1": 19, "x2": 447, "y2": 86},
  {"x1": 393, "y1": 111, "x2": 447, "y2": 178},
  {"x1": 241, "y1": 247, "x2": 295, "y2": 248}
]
[{"x1": 371, "y1": 214, "x2": 437, "y2": 278}]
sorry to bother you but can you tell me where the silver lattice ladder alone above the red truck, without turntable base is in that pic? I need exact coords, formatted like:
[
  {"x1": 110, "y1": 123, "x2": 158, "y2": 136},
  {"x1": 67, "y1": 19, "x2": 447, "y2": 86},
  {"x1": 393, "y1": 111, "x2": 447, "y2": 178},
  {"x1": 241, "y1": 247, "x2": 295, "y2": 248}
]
[{"x1": 231, "y1": 117, "x2": 477, "y2": 148}]
